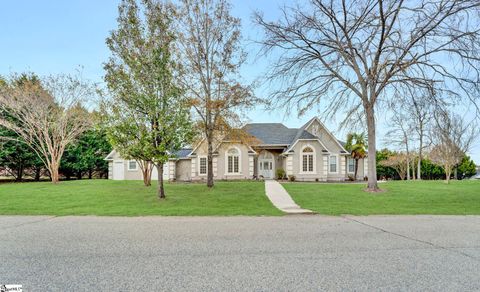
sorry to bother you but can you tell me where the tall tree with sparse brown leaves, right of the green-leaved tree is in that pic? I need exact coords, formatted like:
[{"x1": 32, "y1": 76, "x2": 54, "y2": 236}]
[{"x1": 179, "y1": 0, "x2": 256, "y2": 187}]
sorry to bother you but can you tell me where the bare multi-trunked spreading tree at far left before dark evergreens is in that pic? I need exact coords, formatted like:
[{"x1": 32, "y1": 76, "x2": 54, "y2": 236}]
[{"x1": 0, "y1": 75, "x2": 94, "y2": 183}]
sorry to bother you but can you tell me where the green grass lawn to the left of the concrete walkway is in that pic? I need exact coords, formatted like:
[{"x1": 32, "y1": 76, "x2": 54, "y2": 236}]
[{"x1": 0, "y1": 180, "x2": 282, "y2": 216}]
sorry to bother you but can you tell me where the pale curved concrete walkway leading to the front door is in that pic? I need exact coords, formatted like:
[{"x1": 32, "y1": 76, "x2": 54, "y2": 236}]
[{"x1": 265, "y1": 180, "x2": 313, "y2": 214}]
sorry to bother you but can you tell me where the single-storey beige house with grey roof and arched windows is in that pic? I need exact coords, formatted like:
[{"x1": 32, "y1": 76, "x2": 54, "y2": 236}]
[{"x1": 106, "y1": 118, "x2": 367, "y2": 181}]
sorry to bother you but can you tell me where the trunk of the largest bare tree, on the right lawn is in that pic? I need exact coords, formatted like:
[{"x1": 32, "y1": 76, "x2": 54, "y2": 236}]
[{"x1": 365, "y1": 105, "x2": 379, "y2": 192}]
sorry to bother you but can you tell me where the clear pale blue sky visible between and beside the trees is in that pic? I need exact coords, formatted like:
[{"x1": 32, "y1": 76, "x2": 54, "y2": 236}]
[{"x1": 0, "y1": 0, "x2": 480, "y2": 164}]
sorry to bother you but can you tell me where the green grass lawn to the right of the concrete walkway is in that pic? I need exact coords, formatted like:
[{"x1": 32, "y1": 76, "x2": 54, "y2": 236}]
[{"x1": 283, "y1": 181, "x2": 480, "y2": 215}]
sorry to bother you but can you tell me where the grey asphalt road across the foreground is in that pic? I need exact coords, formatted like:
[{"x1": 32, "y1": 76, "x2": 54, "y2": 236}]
[{"x1": 0, "y1": 215, "x2": 480, "y2": 291}]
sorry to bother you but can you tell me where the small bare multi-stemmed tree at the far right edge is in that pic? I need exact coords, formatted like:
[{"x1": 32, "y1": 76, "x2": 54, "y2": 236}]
[{"x1": 429, "y1": 111, "x2": 479, "y2": 183}]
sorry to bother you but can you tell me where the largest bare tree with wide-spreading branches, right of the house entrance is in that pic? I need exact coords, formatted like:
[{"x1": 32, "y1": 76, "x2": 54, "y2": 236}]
[{"x1": 255, "y1": 0, "x2": 480, "y2": 191}]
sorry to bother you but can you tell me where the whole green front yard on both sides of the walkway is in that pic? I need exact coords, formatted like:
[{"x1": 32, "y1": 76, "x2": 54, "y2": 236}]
[{"x1": 0, "y1": 180, "x2": 480, "y2": 216}]
